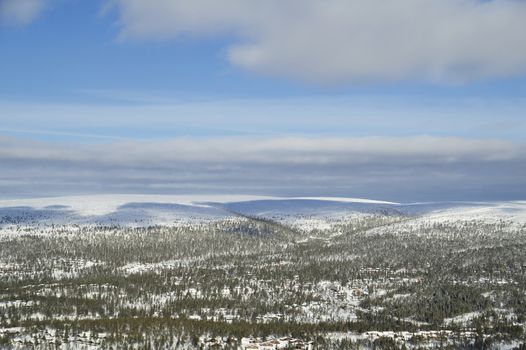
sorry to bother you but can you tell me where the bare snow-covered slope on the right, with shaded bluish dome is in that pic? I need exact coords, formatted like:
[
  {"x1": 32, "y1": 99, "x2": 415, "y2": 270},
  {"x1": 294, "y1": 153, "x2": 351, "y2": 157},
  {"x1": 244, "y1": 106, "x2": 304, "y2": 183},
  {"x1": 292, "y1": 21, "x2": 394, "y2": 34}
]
[{"x1": 224, "y1": 197, "x2": 526, "y2": 232}]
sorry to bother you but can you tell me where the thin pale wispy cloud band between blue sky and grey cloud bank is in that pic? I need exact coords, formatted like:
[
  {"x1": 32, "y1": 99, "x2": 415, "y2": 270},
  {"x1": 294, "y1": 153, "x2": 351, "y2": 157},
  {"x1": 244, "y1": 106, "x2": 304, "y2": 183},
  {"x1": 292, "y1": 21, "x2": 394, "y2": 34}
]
[{"x1": 0, "y1": 93, "x2": 526, "y2": 141}]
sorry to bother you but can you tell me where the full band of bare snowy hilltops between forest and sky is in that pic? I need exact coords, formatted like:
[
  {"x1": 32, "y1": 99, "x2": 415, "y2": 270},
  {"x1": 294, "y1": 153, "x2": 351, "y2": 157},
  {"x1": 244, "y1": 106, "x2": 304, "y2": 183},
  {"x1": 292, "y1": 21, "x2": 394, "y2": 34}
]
[{"x1": 0, "y1": 195, "x2": 526, "y2": 230}]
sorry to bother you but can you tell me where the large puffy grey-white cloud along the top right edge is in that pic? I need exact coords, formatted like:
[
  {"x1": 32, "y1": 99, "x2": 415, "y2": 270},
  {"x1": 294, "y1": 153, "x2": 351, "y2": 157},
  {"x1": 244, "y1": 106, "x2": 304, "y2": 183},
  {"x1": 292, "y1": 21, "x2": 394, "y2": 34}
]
[{"x1": 112, "y1": 0, "x2": 526, "y2": 83}]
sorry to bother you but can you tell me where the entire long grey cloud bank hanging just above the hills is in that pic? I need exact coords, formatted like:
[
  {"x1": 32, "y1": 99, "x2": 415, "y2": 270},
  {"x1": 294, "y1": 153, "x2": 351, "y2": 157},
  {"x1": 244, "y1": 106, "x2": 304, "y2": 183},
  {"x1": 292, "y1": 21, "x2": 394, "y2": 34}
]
[{"x1": 0, "y1": 136, "x2": 526, "y2": 201}]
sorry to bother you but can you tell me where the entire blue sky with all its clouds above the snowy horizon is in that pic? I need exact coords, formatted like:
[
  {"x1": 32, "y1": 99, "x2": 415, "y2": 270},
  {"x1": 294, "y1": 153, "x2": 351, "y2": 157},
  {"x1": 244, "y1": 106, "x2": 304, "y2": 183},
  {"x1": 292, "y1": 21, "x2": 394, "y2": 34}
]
[{"x1": 0, "y1": 0, "x2": 526, "y2": 201}]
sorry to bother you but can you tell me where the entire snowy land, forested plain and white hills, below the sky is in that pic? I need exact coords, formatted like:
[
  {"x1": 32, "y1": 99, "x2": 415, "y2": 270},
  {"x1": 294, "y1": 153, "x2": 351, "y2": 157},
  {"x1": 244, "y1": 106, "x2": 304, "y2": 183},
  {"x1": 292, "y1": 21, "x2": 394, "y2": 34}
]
[{"x1": 0, "y1": 195, "x2": 526, "y2": 349}]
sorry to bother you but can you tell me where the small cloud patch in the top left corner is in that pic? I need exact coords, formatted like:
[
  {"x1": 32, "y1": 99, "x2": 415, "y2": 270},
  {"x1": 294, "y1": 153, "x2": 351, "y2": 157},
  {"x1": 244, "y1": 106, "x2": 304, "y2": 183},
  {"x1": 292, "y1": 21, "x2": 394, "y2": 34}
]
[{"x1": 0, "y1": 0, "x2": 46, "y2": 25}]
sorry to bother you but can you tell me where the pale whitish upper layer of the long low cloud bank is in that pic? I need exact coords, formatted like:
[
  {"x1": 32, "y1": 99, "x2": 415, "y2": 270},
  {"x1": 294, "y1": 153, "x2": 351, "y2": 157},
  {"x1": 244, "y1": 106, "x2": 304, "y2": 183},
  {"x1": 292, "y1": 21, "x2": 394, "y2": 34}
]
[{"x1": 0, "y1": 136, "x2": 526, "y2": 165}]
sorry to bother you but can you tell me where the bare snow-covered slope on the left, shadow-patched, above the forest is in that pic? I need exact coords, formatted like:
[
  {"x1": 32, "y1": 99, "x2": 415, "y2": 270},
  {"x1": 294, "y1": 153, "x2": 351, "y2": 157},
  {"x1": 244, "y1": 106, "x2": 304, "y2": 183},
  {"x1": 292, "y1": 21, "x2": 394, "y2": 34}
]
[{"x1": 0, "y1": 195, "x2": 244, "y2": 226}]
